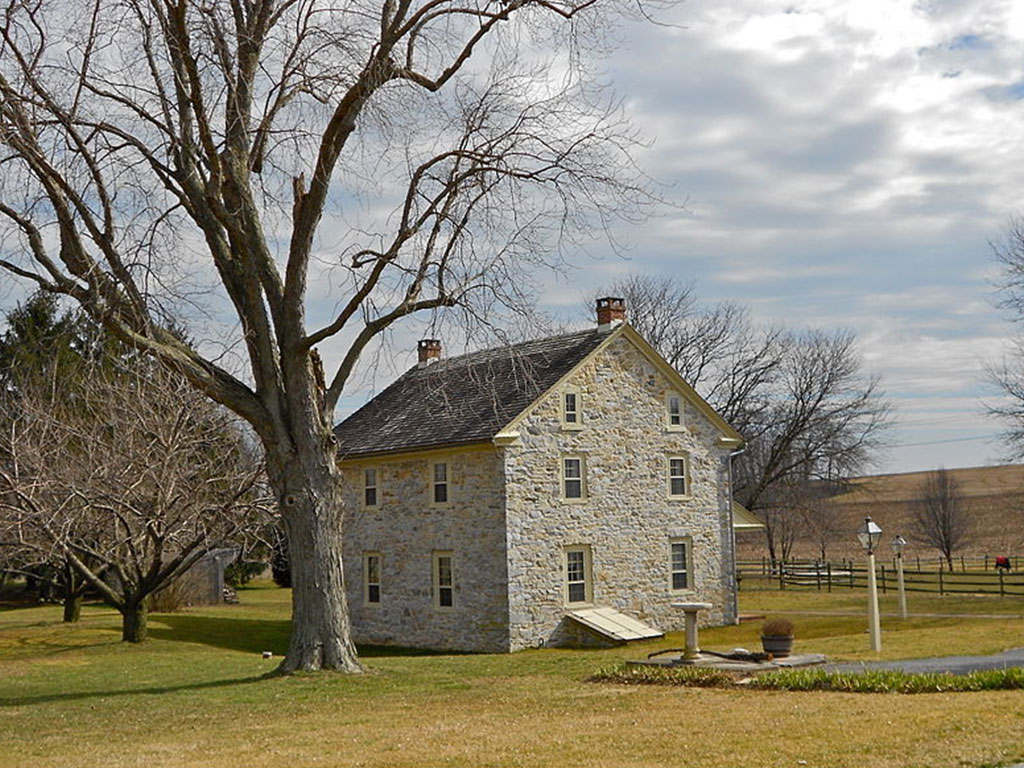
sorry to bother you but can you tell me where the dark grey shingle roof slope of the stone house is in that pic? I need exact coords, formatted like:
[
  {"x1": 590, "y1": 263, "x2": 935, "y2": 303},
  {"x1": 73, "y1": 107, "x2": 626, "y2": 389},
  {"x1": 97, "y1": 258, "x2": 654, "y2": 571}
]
[{"x1": 335, "y1": 328, "x2": 608, "y2": 459}]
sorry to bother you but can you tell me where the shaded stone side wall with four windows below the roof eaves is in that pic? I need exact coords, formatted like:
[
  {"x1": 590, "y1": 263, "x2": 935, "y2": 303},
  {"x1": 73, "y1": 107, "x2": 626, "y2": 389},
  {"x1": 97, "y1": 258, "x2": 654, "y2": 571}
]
[{"x1": 342, "y1": 447, "x2": 509, "y2": 652}]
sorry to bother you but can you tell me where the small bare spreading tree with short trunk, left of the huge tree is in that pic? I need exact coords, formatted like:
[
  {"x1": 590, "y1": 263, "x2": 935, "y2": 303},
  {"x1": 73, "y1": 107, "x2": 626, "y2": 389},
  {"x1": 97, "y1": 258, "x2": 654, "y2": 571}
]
[{"x1": 0, "y1": 359, "x2": 267, "y2": 642}]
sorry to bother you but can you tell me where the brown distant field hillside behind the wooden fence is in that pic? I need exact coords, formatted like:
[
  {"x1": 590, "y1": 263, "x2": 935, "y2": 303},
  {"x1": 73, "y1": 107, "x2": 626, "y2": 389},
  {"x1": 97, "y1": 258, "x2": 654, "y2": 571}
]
[{"x1": 736, "y1": 464, "x2": 1024, "y2": 559}]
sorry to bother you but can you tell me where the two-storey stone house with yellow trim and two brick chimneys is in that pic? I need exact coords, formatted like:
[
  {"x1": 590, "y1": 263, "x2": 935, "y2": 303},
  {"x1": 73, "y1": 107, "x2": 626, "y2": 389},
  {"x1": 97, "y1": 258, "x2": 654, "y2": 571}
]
[{"x1": 336, "y1": 299, "x2": 742, "y2": 651}]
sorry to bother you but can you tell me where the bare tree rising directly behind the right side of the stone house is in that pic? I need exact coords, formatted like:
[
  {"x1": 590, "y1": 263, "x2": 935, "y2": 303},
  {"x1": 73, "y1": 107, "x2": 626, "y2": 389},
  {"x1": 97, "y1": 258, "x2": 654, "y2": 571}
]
[{"x1": 607, "y1": 275, "x2": 889, "y2": 559}]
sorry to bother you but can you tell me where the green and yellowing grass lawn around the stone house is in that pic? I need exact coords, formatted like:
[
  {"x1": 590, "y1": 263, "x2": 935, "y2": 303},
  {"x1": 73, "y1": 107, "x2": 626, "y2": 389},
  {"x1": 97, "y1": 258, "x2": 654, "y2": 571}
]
[{"x1": 0, "y1": 588, "x2": 1024, "y2": 768}]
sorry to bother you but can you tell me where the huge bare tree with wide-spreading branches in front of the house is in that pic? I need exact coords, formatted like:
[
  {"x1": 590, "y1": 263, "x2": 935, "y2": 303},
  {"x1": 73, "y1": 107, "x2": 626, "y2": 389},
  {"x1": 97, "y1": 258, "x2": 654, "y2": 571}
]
[{"x1": 0, "y1": 0, "x2": 651, "y2": 671}]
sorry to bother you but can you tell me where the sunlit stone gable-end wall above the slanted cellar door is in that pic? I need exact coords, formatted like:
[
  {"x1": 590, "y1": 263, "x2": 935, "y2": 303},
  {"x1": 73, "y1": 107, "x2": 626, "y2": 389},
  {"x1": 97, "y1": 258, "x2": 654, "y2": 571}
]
[{"x1": 506, "y1": 336, "x2": 736, "y2": 650}]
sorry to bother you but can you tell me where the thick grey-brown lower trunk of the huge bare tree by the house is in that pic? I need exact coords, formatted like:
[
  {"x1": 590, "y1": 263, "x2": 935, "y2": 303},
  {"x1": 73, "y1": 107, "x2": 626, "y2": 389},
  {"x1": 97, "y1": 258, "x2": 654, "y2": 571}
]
[{"x1": 280, "y1": 446, "x2": 362, "y2": 672}]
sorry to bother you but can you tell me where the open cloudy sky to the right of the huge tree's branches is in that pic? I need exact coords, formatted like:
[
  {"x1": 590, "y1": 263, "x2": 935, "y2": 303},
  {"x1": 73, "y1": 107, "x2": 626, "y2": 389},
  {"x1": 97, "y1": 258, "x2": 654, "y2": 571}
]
[{"x1": 528, "y1": 0, "x2": 1024, "y2": 472}]
